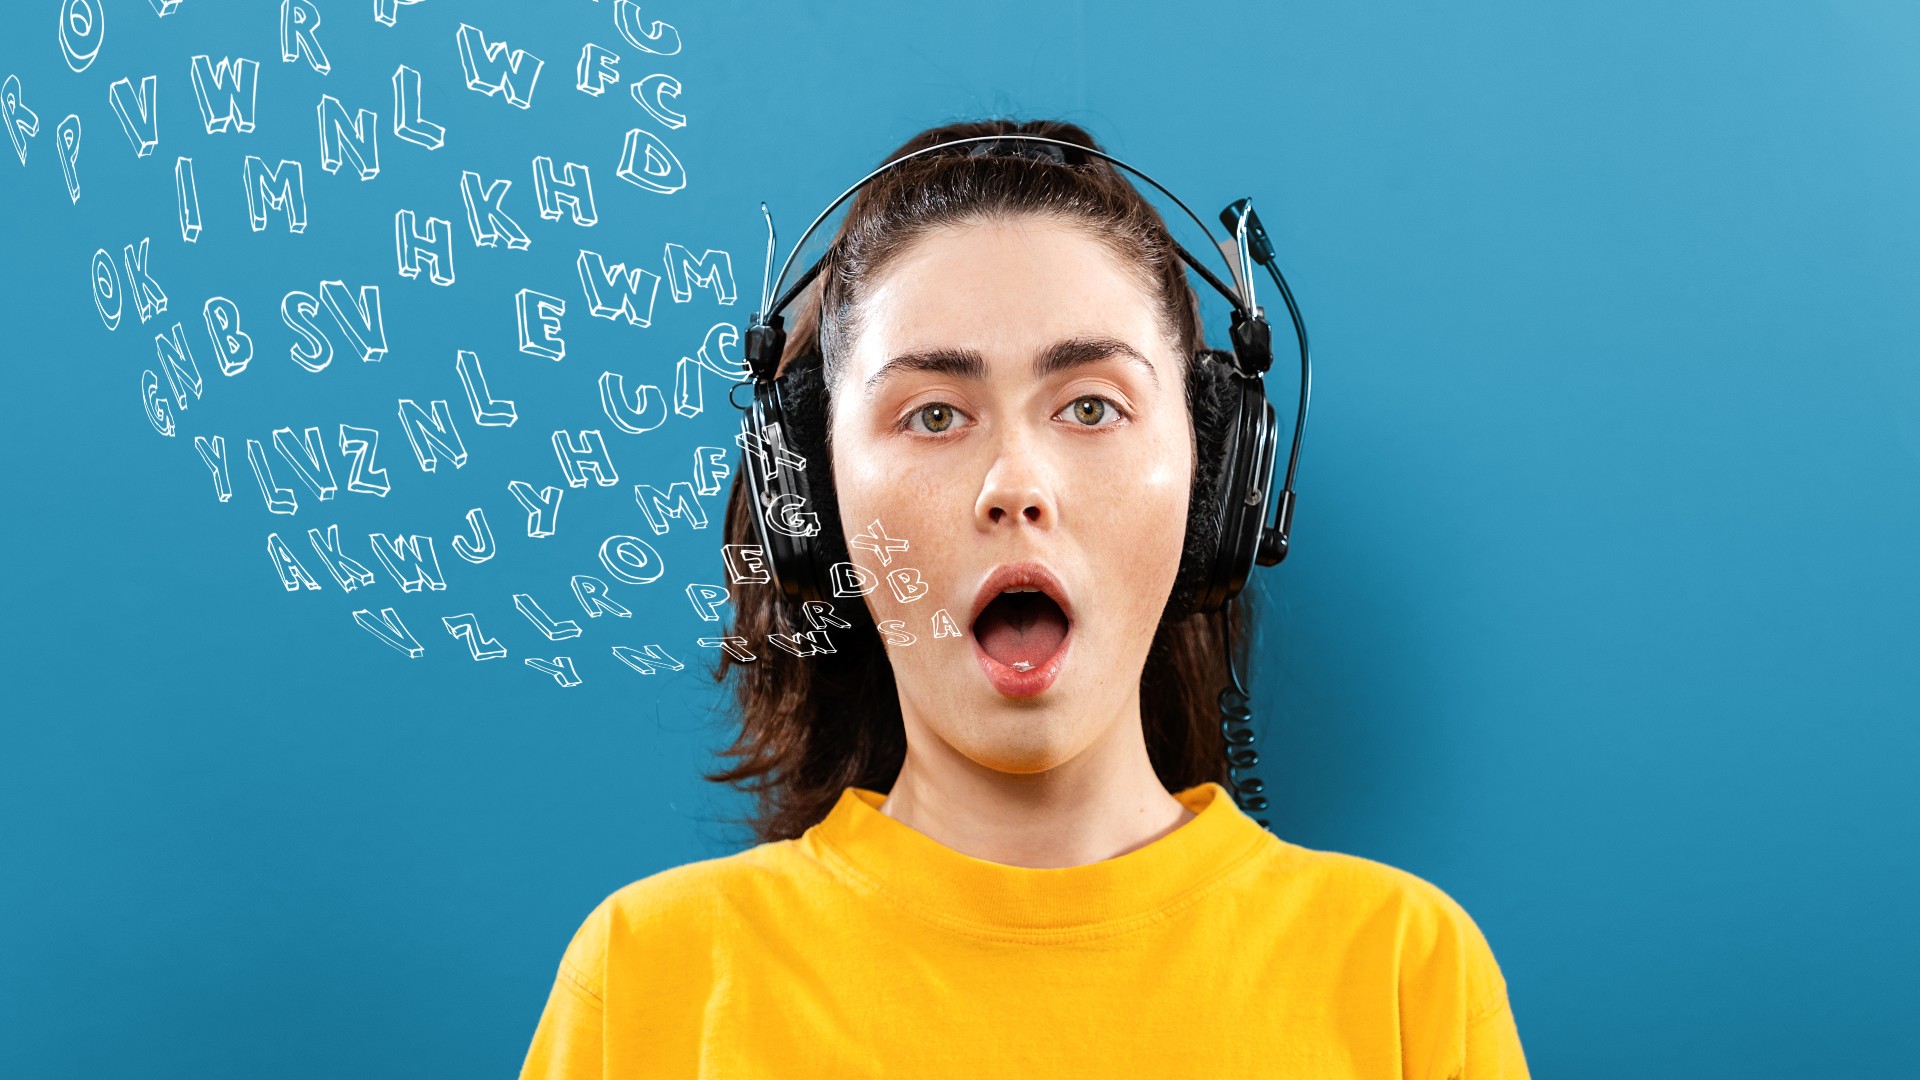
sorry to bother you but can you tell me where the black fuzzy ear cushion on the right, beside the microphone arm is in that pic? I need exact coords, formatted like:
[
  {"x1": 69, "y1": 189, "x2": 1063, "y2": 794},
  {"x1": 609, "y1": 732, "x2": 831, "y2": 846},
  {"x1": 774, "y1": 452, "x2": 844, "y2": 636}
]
[{"x1": 1164, "y1": 350, "x2": 1242, "y2": 621}]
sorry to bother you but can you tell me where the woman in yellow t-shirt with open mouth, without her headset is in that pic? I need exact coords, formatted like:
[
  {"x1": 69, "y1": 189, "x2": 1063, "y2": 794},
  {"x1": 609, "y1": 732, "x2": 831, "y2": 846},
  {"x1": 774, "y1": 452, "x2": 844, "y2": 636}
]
[{"x1": 522, "y1": 121, "x2": 1526, "y2": 1080}]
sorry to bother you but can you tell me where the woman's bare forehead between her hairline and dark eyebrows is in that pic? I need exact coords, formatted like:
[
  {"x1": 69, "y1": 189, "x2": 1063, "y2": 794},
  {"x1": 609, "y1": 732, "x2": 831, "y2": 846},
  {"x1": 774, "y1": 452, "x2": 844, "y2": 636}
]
[{"x1": 845, "y1": 215, "x2": 1171, "y2": 379}]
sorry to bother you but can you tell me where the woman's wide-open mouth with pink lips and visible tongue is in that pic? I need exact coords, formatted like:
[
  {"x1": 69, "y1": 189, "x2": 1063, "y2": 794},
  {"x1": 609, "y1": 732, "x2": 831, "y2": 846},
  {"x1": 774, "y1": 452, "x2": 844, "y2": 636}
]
[{"x1": 968, "y1": 561, "x2": 1073, "y2": 698}]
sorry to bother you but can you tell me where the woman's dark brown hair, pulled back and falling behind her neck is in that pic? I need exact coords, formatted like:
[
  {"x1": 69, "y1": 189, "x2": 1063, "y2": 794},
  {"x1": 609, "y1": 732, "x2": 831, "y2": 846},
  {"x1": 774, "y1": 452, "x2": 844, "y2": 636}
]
[{"x1": 705, "y1": 119, "x2": 1250, "y2": 842}]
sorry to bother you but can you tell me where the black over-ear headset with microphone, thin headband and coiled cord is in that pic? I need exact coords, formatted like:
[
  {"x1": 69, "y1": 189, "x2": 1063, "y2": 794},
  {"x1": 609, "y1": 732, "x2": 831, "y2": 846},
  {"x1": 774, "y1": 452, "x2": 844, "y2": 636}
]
[{"x1": 739, "y1": 135, "x2": 1311, "y2": 826}]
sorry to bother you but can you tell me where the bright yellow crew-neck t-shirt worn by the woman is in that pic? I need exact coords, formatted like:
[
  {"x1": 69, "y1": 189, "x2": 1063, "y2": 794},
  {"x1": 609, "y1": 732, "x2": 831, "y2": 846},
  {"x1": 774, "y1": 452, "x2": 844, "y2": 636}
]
[{"x1": 520, "y1": 782, "x2": 1526, "y2": 1080}]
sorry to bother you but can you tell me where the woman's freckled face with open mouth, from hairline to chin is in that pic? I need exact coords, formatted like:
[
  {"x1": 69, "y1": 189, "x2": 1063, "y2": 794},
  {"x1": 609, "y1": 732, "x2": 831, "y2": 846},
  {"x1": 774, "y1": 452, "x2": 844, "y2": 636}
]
[{"x1": 831, "y1": 215, "x2": 1192, "y2": 774}]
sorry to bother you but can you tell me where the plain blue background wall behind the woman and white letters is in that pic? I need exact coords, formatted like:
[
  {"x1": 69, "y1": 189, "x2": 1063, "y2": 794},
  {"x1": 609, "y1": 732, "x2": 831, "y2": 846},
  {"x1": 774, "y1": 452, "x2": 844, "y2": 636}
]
[{"x1": 0, "y1": 0, "x2": 1920, "y2": 1078}]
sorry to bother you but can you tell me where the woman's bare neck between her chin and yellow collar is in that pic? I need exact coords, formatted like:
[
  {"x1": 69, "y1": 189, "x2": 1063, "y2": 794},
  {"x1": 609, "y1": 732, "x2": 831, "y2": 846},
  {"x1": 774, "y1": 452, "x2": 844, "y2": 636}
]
[{"x1": 879, "y1": 694, "x2": 1194, "y2": 869}]
